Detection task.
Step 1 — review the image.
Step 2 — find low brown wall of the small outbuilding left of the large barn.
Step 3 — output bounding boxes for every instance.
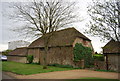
[7,56,27,63]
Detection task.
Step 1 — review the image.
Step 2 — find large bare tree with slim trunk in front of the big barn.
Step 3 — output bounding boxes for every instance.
[9,1,77,69]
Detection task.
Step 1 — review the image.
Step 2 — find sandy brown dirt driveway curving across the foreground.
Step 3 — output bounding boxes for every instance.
[6,70,118,79]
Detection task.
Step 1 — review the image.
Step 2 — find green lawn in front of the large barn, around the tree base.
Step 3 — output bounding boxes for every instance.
[2,61,73,75]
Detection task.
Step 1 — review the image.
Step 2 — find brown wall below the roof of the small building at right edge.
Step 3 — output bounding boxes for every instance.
[108,54,120,72]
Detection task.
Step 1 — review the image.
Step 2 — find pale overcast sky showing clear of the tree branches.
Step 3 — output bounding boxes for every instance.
[0,0,108,52]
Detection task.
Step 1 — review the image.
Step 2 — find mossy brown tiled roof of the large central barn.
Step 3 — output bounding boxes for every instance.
[29,28,90,47]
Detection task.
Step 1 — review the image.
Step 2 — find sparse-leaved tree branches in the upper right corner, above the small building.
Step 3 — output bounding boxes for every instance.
[87,0,120,41]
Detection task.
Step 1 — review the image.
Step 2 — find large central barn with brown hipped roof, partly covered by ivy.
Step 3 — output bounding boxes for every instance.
[27,28,93,67]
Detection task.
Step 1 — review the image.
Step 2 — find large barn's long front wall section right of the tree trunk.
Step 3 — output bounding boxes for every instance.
[48,46,73,65]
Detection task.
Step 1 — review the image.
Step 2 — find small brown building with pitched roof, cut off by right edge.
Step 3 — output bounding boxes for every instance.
[103,40,120,72]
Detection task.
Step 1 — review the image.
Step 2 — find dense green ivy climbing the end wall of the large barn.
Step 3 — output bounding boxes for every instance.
[73,43,93,67]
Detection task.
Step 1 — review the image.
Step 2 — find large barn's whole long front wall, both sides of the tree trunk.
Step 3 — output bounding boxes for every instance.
[28,46,74,65]
